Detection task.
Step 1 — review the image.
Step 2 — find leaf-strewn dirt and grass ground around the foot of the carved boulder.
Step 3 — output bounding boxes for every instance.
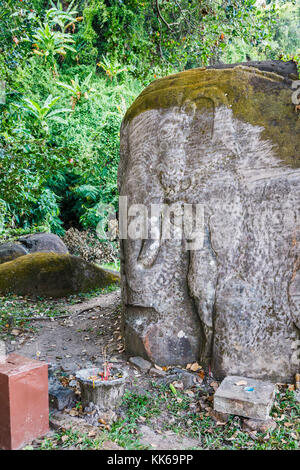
[2,290,300,450]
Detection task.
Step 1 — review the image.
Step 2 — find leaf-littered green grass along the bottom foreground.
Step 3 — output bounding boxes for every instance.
[34,385,300,450]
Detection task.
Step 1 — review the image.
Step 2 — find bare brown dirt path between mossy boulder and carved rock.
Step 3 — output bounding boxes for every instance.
[15,290,123,372]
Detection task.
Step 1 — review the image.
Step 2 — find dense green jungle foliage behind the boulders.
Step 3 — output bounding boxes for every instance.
[0,0,300,236]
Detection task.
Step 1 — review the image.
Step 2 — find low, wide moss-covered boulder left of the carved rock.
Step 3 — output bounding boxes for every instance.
[0,253,119,297]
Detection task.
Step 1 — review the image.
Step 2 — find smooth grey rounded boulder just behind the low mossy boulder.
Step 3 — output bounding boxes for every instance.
[18,233,68,254]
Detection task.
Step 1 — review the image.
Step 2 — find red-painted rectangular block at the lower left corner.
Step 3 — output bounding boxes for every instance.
[0,354,49,450]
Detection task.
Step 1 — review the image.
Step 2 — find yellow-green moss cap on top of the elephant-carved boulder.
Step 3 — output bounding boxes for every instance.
[123,65,300,168]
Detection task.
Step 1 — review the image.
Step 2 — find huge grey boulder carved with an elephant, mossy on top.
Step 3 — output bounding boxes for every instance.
[119,59,300,380]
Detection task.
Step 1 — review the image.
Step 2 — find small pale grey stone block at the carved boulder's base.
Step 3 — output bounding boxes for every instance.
[214,376,275,420]
